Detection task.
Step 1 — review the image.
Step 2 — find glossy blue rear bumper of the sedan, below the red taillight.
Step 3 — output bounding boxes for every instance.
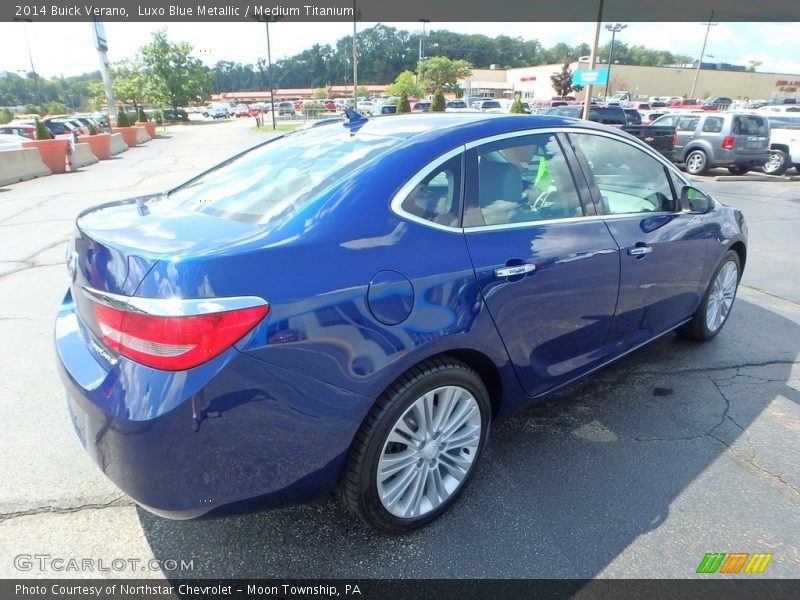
[56,295,372,519]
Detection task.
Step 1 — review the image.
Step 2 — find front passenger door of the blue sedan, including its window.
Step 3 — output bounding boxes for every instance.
[570,132,709,355]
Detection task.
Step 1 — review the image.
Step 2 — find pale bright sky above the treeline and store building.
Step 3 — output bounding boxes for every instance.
[0,22,800,77]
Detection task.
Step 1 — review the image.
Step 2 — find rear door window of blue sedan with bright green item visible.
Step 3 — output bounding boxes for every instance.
[472,133,584,225]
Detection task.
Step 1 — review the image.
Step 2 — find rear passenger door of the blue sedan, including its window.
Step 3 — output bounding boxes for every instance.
[464,132,619,395]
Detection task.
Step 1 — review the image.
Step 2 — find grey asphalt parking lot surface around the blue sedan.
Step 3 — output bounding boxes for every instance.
[0,119,800,578]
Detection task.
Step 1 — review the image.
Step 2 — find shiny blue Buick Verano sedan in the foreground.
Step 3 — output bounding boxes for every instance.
[55,112,747,532]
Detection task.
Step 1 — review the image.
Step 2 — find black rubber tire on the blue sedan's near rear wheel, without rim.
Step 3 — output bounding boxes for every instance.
[338,357,491,533]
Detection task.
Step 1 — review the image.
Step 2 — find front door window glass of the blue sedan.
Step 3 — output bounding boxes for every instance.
[573,134,676,215]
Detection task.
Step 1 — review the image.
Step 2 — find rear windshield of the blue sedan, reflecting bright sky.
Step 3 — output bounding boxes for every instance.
[168,124,398,223]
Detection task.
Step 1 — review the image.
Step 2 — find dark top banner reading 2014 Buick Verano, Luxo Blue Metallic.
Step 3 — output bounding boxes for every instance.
[0,0,800,24]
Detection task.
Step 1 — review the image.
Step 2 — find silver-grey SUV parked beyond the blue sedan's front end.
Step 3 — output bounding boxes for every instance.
[672,113,770,175]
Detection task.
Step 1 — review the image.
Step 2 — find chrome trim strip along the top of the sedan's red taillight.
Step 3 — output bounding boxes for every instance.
[81,285,269,317]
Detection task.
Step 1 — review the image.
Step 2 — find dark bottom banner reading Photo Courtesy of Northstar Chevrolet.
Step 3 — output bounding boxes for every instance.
[0,575,800,600]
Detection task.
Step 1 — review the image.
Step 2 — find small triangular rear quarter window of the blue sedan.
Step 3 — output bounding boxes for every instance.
[401,155,461,227]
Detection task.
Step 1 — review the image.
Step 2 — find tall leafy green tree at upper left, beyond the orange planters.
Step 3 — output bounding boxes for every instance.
[141,29,212,113]
